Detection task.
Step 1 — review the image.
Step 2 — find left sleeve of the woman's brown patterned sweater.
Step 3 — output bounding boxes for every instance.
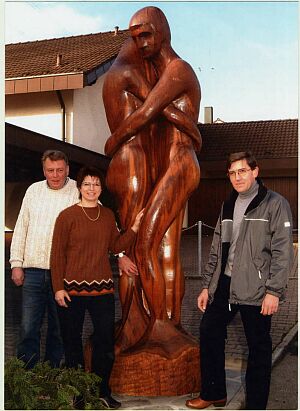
[50,212,71,293]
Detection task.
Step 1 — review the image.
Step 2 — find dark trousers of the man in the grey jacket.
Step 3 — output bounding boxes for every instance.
[200,275,272,410]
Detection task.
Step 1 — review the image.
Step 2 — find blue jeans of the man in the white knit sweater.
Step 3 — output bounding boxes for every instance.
[17,268,63,368]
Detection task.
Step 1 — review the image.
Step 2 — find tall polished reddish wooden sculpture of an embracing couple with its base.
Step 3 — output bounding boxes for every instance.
[103,7,201,395]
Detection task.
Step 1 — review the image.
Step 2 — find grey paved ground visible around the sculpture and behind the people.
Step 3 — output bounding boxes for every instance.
[5,235,298,410]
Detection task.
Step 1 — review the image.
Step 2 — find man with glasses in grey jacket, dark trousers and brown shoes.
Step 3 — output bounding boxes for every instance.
[186,152,293,409]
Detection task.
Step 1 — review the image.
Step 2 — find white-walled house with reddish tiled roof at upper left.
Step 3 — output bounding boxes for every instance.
[5,27,129,153]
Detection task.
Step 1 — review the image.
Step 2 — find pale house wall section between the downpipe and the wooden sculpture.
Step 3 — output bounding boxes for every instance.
[73,75,110,154]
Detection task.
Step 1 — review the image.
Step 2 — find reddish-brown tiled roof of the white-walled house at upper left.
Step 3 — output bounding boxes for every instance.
[5,30,129,79]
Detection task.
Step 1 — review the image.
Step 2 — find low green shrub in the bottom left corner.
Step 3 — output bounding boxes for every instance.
[4,358,103,410]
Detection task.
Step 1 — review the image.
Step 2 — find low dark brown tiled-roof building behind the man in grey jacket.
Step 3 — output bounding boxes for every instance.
[189,119,298,227]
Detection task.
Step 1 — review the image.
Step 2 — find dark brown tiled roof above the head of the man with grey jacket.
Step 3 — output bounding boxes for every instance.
[198,120,298,161]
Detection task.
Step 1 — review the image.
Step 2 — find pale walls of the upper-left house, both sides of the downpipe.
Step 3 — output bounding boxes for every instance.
[5,75,110,154]
